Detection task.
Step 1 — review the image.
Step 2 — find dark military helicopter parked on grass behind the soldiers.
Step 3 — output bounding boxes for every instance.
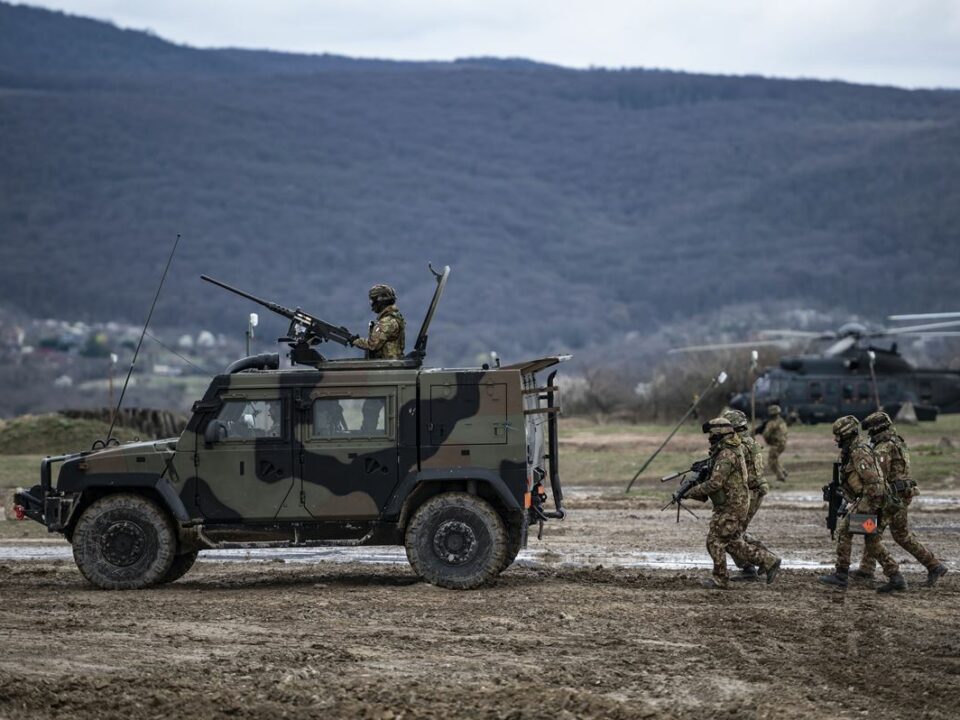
[670,313,960,423]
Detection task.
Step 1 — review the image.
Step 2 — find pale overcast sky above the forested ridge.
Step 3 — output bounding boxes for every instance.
[18,0,960,88]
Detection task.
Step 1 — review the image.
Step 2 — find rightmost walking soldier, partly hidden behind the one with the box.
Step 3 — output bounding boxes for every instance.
[851,412,947,586]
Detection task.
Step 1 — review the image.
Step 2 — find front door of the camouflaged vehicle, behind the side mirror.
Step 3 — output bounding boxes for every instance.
[196,389,295,522]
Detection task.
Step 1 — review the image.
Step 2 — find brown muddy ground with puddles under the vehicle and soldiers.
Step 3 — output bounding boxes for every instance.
[0,487,960,720]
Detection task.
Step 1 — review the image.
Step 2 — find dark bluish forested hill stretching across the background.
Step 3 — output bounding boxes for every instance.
[0,4,960,362]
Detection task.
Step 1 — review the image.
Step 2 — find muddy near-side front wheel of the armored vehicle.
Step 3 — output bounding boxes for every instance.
[73,494,177,590]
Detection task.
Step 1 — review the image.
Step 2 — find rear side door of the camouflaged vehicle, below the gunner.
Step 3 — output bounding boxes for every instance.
[297,386,399,520]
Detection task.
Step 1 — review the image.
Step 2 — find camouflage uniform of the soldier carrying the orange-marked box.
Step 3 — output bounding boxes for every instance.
[837,430,900,578]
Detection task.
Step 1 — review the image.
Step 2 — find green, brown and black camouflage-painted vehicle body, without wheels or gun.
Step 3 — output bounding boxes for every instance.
[39,360,553,547]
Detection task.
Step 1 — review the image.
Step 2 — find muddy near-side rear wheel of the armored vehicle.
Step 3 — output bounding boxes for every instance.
[406,492,507,590]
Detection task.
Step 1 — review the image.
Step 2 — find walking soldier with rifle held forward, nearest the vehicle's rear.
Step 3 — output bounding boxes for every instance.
[686,417,780,589]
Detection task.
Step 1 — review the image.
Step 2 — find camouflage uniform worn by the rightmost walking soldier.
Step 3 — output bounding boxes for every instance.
[858,423,940,577]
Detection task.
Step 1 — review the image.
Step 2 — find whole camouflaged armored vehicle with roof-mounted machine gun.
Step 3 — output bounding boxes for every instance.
[15,268,565,589]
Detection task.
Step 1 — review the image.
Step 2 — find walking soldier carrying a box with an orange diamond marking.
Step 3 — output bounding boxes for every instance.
[820,415,907,593]
